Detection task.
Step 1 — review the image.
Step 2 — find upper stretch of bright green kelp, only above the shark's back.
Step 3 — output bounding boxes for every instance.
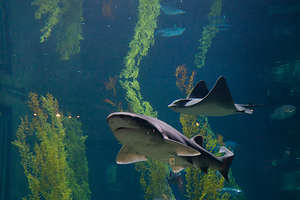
[120,0,160,117]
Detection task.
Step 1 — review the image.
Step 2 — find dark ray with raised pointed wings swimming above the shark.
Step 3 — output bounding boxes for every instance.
[168,76,255,116]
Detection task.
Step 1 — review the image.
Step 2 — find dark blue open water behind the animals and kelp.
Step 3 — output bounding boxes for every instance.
[0,0,300,200]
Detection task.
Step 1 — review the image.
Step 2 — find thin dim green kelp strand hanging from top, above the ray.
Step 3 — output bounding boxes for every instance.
[194,0,222,68]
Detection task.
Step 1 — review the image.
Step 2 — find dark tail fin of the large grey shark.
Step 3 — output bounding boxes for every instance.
[219,146,234,182]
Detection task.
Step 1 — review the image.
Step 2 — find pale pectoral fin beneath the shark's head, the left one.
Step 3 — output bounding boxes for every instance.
[116,145,147,164]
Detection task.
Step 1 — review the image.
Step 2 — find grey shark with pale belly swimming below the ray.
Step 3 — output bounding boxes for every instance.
[107,112,234,181]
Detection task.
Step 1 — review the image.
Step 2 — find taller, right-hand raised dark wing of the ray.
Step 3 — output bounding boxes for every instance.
[204,76,236,110]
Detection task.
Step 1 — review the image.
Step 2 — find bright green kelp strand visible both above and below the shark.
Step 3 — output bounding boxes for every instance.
[120,0,176,199]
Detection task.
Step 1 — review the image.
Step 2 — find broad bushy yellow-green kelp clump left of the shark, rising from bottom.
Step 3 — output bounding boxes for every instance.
[12,93,90,200]
